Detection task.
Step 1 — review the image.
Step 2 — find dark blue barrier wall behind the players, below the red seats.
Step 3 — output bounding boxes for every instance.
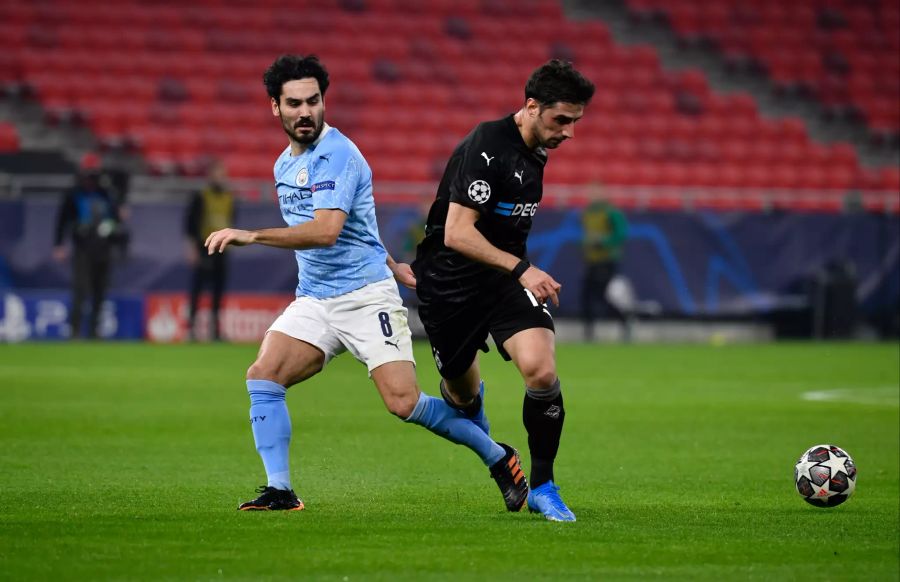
[0,201,900,316]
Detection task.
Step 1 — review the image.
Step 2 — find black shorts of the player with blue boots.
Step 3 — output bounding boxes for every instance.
[419,276,555,380]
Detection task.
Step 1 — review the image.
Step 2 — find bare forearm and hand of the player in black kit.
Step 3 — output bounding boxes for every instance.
[444,202,562,306]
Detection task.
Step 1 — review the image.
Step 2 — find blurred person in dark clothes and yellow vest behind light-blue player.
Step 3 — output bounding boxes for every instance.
[185,162,235,341]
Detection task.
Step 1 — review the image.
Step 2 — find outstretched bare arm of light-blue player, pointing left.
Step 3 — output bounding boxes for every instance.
[205,208,347,254]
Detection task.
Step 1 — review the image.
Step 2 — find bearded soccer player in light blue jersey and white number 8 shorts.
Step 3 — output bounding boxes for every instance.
[206,55,528,511]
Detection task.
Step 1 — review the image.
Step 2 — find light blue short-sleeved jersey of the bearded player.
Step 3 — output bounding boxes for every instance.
[275,124,391,299]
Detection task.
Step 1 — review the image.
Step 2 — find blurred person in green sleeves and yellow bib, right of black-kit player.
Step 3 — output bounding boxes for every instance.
[581,199,631,341]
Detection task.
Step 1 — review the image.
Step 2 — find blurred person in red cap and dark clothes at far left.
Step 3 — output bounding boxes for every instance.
[53,153,128,339]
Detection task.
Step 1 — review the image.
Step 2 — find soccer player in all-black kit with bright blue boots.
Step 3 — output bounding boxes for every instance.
[413,60,594,521]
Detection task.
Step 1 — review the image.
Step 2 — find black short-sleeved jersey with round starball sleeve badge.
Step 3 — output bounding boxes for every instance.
[413,115,547,302]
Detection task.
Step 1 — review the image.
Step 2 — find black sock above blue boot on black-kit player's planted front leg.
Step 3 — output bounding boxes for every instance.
[522,379,566,489]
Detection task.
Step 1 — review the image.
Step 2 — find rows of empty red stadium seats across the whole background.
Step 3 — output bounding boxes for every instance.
[0,0,900,210]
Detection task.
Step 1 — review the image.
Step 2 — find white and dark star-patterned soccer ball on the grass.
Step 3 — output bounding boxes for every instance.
[794,445,856,507]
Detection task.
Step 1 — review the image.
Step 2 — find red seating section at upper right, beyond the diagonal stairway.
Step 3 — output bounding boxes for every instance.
[628,0,900,136]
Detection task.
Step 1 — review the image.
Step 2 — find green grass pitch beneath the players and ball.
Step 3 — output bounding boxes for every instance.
[0,344,900,582]
